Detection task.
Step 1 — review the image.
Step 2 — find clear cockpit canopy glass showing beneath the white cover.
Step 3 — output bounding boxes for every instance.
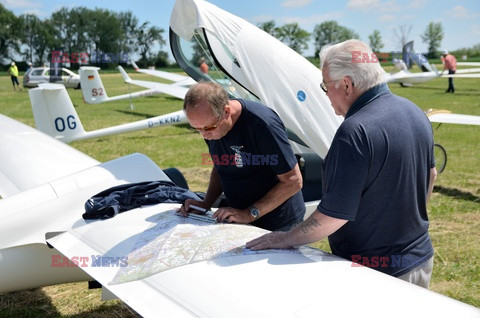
[170,29,258,101]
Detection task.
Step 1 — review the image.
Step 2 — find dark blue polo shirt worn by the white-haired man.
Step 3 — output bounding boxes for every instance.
[318,84,435,276]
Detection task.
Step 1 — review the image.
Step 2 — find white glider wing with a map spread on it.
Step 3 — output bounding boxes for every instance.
[48,204,479,318]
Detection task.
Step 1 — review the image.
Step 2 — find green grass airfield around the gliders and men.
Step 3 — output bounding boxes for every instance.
[0,66,480,317]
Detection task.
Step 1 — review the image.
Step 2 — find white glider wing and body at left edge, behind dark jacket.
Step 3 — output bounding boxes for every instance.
[0,115,174,293]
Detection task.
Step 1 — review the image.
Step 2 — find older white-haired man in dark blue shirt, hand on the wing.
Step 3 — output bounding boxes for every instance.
[246,40,437,287]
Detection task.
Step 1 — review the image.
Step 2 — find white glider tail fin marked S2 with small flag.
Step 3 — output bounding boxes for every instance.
[78,66,109,104]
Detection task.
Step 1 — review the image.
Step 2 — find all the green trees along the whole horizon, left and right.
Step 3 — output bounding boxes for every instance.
[0,3,480,68]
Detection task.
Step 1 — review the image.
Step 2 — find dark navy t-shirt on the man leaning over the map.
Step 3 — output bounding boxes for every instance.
[205,99,305,231]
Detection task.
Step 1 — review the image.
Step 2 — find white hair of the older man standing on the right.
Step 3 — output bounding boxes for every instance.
[320,40,386,93]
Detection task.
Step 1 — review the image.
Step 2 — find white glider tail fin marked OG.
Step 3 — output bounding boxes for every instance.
[28,83,85,142]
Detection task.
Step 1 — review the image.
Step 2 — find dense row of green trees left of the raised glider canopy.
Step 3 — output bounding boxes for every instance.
[0,3,168,67]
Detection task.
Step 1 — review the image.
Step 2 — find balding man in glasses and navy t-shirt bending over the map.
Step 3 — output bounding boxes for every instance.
[181,82,305,231]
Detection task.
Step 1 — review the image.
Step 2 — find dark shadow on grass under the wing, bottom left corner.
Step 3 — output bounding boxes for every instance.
[0,288,141,318]
